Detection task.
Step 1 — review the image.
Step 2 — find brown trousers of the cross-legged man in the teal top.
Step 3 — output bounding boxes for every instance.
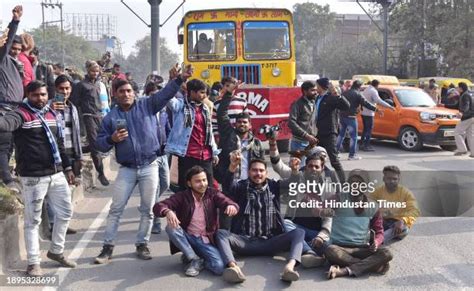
[324,245,392,277]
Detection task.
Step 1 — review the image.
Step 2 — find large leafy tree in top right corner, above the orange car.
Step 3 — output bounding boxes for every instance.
[389,0,474,78]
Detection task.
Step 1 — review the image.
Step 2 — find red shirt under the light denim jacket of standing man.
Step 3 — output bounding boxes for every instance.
[186,105,212,161]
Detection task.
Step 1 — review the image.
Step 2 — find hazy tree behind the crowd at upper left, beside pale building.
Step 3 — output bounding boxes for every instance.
[28,26,101,71]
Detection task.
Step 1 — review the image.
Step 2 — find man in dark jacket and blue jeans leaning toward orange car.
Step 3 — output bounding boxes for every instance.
[336,80,377,160]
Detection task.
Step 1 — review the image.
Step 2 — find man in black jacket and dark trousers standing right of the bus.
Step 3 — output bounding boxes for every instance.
[315,78,350,182]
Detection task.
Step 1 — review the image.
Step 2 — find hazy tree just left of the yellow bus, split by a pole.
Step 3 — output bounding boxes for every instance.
[122,35,178,82]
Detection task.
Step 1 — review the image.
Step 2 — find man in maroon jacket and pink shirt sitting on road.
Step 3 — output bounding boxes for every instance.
[153,166,239,277]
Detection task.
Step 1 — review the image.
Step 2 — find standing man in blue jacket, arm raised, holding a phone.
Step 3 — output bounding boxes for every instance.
[95,68,192,264]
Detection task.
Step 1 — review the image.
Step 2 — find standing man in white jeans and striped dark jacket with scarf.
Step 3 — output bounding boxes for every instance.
[0,81,76,276]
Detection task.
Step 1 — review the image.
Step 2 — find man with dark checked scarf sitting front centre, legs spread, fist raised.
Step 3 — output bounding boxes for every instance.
[216,153,304,283]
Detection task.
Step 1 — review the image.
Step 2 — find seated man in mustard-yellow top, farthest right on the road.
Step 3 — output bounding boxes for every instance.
[371,166,420,243]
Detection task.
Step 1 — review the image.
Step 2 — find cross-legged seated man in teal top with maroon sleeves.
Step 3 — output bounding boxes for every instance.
[324,170,392,279]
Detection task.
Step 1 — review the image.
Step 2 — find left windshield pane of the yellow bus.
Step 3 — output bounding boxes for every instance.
[188,22,236,61]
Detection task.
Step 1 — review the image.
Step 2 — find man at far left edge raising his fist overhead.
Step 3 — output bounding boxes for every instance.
[0,5,23,193]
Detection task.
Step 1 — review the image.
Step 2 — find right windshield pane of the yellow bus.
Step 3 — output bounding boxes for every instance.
[244,21,291,60]
